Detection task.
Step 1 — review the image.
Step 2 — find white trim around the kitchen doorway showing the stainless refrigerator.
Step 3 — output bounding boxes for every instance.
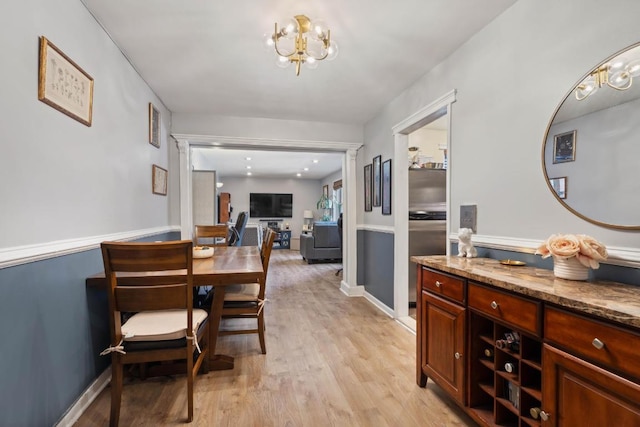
[392,89,456,331]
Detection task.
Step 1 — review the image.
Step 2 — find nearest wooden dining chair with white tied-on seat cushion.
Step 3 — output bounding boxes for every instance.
[101,240,209,426]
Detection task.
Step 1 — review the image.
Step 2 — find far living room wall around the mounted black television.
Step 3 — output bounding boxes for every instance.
[220,176,322,237]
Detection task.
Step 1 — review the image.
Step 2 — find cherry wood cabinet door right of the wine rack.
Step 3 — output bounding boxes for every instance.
[542,345,640,427]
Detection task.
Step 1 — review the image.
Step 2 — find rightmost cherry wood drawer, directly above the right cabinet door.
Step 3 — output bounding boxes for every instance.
[544,307,640,378]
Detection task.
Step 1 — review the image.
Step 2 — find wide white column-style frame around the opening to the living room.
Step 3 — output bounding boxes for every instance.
[171,134,362,296]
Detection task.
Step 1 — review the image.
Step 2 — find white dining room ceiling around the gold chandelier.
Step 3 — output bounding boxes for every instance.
[81,0,516,177]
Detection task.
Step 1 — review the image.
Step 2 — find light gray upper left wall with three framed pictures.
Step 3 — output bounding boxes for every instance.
[0,0,179,248]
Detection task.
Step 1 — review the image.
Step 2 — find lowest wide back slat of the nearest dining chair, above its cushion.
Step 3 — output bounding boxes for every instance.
[115,283,192,312]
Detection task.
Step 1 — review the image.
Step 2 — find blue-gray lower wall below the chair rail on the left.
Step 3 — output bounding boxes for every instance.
[0,232,180,426]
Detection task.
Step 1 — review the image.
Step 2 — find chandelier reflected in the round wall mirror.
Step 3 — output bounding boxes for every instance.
[575,57,640,101]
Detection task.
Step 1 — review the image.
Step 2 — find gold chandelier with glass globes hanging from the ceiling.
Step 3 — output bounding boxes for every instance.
[265,15,338,76]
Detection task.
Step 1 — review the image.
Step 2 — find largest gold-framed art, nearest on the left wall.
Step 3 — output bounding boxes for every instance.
[38,36,93,126]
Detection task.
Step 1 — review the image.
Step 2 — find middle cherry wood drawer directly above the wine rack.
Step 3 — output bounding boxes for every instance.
[468,283,542,337]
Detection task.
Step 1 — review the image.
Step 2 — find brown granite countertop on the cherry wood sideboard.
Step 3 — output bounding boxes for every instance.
[411,255,640,328]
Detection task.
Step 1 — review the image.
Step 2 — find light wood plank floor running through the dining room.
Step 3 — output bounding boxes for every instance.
[76,250,475,427]
